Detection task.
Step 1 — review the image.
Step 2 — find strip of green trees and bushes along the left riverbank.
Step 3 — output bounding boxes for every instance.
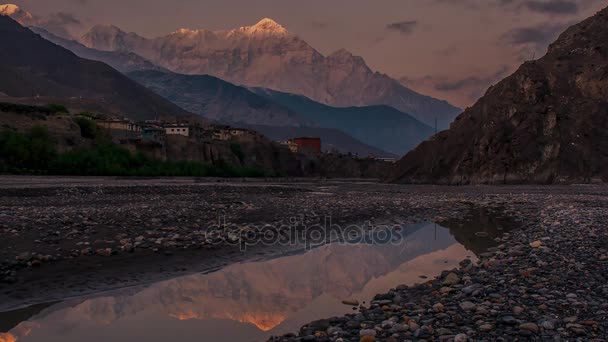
[0,125,264,177]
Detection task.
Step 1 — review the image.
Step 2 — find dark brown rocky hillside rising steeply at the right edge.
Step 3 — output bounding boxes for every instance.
[390,9,608,184]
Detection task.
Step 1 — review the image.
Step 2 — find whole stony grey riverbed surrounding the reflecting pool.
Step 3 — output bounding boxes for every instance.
[0,177,608,341]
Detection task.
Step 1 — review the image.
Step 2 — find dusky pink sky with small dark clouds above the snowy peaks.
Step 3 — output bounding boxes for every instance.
[11,0,608,108]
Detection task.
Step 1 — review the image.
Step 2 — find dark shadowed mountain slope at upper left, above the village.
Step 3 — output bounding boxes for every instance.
[0,15,187,119]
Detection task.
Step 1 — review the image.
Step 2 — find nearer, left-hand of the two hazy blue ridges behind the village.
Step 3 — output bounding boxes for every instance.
[127,71,391,156]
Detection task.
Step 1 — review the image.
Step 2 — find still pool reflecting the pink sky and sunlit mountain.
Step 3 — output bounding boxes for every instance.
[0,219,510,342]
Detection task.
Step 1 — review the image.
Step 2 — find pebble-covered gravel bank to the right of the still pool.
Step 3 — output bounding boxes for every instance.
[273,186,608,341]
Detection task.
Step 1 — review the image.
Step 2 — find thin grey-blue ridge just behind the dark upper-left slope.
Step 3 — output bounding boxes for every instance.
[29,26,164,73]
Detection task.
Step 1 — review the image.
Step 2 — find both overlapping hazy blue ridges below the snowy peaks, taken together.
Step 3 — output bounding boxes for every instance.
[128,71,433,156]
